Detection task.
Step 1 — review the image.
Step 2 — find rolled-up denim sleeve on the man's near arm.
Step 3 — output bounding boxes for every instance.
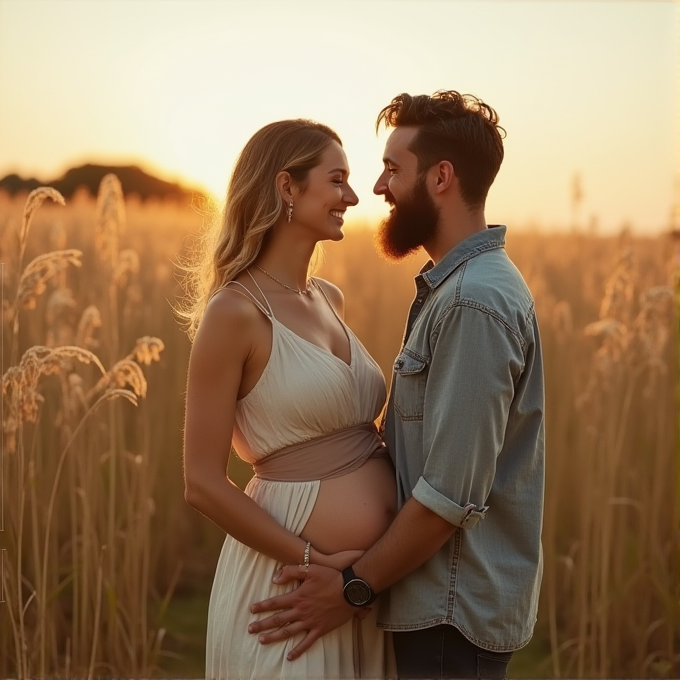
[413,303,524,529]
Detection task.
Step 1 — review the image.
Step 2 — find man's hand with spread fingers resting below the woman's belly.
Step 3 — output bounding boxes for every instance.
[248,564,370,661]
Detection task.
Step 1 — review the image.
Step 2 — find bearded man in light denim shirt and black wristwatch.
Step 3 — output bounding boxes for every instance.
[249,91,545,678]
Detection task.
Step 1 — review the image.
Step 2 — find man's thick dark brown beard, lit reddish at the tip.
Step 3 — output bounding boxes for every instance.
[375,177,439,260]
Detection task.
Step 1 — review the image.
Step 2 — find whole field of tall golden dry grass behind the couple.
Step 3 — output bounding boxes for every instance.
[0,182,680,678]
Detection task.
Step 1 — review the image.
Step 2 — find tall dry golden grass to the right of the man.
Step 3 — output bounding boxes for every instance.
[504,233,680,677]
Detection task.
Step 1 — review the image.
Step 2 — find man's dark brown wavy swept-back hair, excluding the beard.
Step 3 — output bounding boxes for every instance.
[375,90,505,208]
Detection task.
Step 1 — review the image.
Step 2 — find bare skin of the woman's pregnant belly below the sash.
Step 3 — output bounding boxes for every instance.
[302,458,397,554]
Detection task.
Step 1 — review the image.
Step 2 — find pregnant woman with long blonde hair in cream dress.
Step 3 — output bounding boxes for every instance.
[184,120,396,680]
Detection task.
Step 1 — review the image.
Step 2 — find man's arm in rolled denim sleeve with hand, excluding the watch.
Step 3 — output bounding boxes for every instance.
[249,306,523,658]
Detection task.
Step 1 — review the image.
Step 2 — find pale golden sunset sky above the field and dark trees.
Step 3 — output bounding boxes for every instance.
[0,0,680,231]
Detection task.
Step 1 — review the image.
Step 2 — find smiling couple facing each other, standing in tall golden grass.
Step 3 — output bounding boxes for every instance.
[184,91,544,680]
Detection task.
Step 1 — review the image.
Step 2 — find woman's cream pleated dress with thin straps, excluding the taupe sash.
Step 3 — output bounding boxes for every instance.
[206,284,391,680]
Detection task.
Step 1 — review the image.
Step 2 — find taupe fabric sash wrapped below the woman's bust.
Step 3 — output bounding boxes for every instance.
[253,423,389,482]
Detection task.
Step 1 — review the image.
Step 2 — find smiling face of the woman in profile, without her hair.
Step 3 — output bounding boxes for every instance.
[292,141,359,241]
